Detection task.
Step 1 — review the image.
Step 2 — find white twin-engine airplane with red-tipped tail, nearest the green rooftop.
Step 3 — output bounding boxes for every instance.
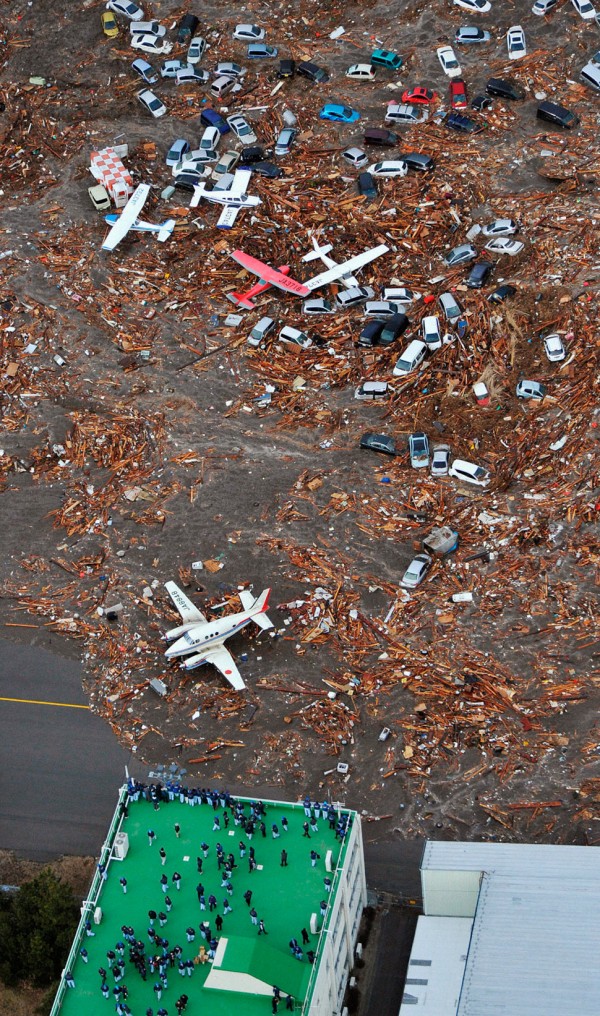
[162,582,273,692]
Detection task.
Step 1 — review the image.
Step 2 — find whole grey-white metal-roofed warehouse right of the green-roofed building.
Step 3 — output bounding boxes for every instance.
[400,842,600,1016]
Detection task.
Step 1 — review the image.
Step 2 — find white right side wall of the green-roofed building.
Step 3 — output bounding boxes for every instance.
[303,815,366,1016]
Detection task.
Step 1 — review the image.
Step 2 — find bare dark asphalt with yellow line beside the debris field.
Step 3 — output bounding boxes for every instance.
[0,639,145,861]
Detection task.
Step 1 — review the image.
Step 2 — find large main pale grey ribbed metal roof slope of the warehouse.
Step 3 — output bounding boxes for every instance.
[454,873,600,1016]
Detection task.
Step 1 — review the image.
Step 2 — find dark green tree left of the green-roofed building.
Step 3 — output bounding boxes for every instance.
[0,868,79,988]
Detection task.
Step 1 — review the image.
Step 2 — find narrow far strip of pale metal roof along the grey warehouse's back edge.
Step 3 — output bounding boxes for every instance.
[421,840,600,884]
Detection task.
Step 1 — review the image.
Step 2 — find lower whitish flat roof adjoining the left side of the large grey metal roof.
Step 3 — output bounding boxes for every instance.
[400,917,473,1016]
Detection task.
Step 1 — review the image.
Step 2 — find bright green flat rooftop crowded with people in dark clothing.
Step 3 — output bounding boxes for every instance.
[53,799,355,1016]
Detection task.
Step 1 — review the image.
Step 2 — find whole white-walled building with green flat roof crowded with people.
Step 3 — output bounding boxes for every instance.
[52,787,366,1016]
